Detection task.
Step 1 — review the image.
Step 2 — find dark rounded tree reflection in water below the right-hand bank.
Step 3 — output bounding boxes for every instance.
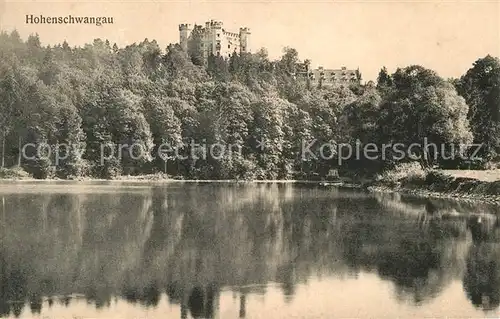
[344,196,465,304]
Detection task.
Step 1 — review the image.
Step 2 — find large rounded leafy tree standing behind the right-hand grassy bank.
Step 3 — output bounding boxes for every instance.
[378,65,472,167]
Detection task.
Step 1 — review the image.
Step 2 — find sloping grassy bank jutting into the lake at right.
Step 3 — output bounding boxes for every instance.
[372,165,500,203]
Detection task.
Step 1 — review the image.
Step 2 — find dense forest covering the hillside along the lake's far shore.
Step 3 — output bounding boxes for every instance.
[0,31,500,179]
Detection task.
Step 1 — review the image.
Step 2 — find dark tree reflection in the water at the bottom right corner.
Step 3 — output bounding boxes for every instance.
[463,243,500,310]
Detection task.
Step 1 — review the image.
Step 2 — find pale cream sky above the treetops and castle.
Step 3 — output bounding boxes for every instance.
[0,0,500,81]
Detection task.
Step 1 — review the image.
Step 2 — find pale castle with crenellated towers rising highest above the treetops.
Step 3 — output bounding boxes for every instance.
[179,20,250,58]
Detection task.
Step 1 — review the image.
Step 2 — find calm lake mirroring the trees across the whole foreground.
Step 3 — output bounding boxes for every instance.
[0,182,500,319]
